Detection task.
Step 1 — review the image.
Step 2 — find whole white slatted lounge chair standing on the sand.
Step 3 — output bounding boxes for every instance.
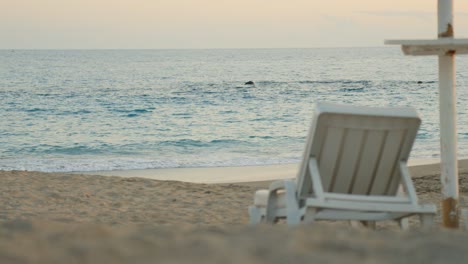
[249,103,437,229]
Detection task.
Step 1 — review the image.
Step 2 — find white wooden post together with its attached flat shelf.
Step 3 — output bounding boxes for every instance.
[385,0,468,228]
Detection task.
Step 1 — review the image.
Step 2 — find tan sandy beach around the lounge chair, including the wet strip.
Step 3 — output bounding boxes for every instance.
[0,160,468,264]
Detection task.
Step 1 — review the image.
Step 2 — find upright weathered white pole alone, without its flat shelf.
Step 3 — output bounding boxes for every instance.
[438,0,458,228]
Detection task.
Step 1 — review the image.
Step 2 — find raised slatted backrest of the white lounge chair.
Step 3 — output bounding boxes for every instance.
[297,103,421,197]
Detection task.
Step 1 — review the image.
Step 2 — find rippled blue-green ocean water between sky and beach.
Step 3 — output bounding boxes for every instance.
[0,47,468,172]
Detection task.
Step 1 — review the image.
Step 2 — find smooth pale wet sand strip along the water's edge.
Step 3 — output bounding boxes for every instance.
[78,158,468,184]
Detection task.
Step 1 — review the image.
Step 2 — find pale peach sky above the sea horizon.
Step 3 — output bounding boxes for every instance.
[0,0,468,49]
